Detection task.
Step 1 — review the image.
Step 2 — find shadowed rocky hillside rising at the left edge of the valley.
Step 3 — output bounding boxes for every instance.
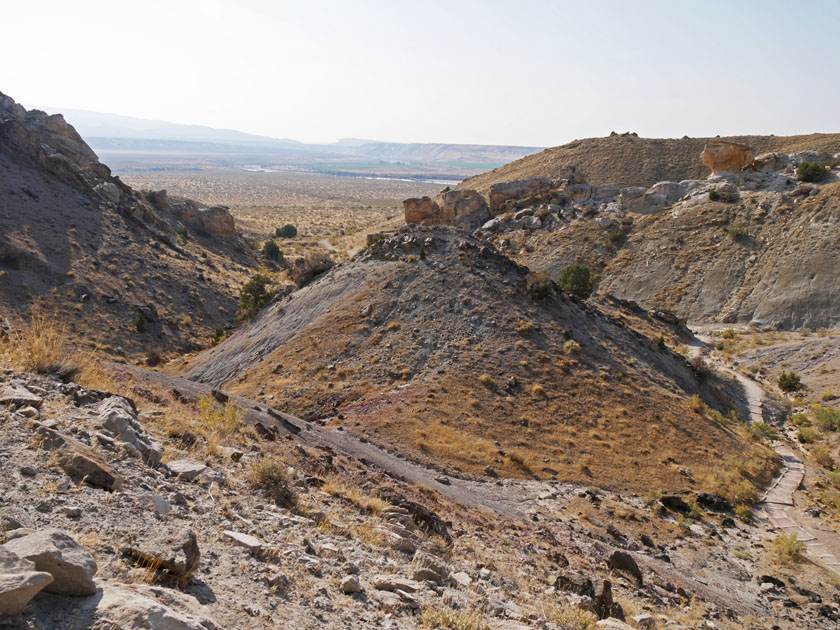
[0,94,254,356]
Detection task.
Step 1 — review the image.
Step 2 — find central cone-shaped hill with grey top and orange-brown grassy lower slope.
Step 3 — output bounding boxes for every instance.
[180,228,776,498]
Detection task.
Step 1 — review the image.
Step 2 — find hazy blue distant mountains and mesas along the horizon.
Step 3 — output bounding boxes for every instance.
[32,108,542,178]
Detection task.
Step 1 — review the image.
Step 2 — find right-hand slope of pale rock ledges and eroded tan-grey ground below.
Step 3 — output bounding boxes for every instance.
[452,142,840,329]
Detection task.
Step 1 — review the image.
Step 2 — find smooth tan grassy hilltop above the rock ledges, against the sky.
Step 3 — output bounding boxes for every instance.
[458,134,840,196]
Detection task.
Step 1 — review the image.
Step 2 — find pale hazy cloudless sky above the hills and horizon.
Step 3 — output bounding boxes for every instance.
[0,0,840,146]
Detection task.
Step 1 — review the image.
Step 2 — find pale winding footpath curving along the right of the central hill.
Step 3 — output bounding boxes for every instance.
[694,334,840,574]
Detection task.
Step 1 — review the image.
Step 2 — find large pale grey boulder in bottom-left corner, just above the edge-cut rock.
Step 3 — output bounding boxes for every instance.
[3,529,97,596]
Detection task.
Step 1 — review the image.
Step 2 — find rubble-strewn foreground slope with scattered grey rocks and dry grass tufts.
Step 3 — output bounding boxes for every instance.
[0,360,840,630]
